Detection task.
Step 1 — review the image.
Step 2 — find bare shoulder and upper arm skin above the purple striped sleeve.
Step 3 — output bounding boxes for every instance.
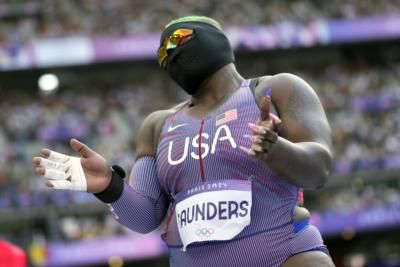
[136,102,186,159]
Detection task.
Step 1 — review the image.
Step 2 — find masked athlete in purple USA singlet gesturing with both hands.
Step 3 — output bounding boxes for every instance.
[33,16,334,267]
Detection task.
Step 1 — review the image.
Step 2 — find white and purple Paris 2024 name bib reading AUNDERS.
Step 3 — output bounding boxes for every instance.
[175,180,252,251]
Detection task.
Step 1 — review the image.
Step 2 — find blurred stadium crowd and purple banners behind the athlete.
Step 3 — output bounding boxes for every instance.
[0,0,400,267]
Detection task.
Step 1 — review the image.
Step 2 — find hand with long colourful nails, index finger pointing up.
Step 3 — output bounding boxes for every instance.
[240,89,281,158]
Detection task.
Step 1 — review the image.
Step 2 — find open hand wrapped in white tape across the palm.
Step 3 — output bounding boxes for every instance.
[32,139,111,193]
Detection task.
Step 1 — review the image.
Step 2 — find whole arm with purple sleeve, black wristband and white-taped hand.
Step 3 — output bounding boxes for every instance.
[33,112,169,233]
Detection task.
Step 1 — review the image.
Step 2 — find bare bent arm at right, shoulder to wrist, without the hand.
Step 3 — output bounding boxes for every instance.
[256,73,333,189]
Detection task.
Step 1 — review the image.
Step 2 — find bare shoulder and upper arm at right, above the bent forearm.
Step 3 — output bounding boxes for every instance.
[255,73,331,147]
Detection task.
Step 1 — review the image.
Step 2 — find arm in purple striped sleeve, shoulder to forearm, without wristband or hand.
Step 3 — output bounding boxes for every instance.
[104,111,169,233]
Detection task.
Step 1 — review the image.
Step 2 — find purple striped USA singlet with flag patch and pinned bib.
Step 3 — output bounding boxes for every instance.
[156,80,326,267]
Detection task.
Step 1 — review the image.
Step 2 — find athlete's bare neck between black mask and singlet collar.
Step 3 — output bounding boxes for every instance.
[191,63,244,108]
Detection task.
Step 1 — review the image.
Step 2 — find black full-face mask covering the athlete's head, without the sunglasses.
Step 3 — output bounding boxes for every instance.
[160,21,234,95]
